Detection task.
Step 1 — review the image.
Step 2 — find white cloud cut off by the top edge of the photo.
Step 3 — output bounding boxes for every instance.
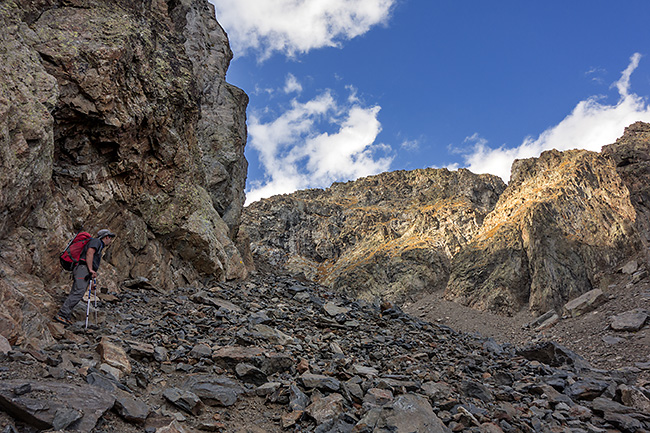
[210,0,397,59]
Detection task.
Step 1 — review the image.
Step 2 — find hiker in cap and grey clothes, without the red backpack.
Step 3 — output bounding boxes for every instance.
[54,229,115,325]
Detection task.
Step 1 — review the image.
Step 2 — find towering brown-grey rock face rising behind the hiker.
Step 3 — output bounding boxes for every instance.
[0,0,248,342]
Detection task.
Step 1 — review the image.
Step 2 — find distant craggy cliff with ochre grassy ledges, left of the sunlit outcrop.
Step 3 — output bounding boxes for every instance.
[242,169,505,299]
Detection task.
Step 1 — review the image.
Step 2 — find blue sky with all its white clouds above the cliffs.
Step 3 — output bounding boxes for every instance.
[211,0,650,202]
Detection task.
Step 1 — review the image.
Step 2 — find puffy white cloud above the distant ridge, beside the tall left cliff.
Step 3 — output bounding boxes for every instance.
[246,92,392,203]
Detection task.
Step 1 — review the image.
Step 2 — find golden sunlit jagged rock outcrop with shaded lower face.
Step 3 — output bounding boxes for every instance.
[446,150,640,314]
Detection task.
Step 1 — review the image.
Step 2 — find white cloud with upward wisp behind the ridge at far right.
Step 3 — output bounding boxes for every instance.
[456,53,650,181]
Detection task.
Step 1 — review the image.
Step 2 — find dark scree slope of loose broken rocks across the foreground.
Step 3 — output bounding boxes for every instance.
[0,275,650,433]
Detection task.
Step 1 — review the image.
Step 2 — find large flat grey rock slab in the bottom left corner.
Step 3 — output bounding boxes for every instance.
[0,379,115,432]
